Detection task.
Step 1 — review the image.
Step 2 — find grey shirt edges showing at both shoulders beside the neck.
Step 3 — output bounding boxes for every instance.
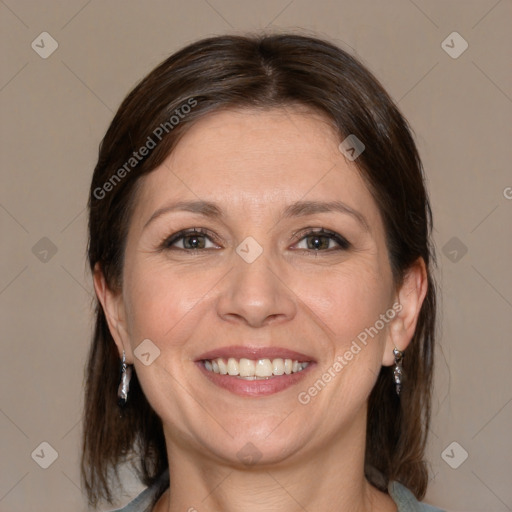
[108,470,443,512]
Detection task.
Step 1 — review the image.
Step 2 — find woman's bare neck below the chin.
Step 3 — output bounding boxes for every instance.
[155,412,397,512]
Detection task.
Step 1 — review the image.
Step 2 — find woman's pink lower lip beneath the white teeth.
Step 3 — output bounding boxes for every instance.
[196,361,315,396]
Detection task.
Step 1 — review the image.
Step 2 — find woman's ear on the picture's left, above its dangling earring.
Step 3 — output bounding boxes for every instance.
[93,263,133,364]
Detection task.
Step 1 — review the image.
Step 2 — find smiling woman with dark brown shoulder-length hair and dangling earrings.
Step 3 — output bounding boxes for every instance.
[82,34,438,512]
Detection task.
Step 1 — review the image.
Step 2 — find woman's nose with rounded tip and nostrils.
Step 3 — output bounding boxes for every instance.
[217,249,297,327]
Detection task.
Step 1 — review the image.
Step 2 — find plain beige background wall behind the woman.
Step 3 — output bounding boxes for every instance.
[0,0,512,512]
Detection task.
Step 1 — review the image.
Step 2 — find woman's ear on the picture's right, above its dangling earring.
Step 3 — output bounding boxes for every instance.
[382,258,428,366]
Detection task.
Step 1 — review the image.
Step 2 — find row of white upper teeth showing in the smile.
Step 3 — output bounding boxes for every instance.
[204,357,309,380]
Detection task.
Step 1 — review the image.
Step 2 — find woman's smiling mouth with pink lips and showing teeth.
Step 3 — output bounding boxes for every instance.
[195,346,316,396]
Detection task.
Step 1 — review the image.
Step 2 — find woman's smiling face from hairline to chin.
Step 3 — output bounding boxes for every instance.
[110,108,399,464]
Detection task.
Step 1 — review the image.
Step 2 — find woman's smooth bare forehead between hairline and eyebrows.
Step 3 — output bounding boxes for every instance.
[130,107,379,227]
